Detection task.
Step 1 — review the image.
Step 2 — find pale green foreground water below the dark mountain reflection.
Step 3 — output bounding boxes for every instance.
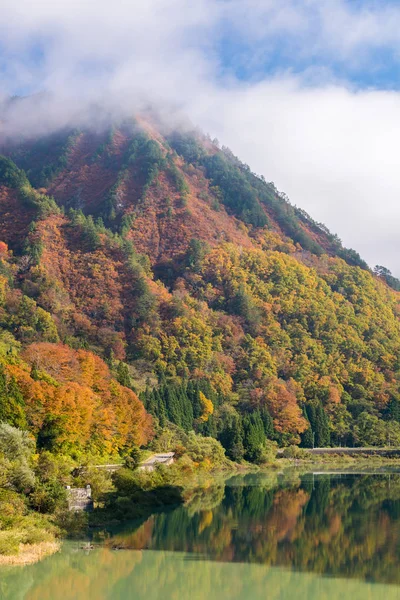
[4,549,398,600]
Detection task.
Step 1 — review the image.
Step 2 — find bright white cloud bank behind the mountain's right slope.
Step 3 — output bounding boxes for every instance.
[196,80,400,275]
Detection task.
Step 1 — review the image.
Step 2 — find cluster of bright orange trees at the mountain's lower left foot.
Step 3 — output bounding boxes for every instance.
[13,343,153,453]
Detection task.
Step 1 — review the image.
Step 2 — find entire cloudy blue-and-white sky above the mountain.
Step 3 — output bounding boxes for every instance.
[0,0,400,277]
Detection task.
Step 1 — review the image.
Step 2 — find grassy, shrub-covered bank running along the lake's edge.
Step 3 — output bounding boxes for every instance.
[0,426,400,565]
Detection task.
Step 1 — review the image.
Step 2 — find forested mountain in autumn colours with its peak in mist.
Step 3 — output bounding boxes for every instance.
[0,115,400,461]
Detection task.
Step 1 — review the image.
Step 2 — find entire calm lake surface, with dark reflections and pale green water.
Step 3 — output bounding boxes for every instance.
[0,474,400,600]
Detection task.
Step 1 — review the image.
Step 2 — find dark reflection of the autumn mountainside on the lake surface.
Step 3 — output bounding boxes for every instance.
[112,475,400,582]
